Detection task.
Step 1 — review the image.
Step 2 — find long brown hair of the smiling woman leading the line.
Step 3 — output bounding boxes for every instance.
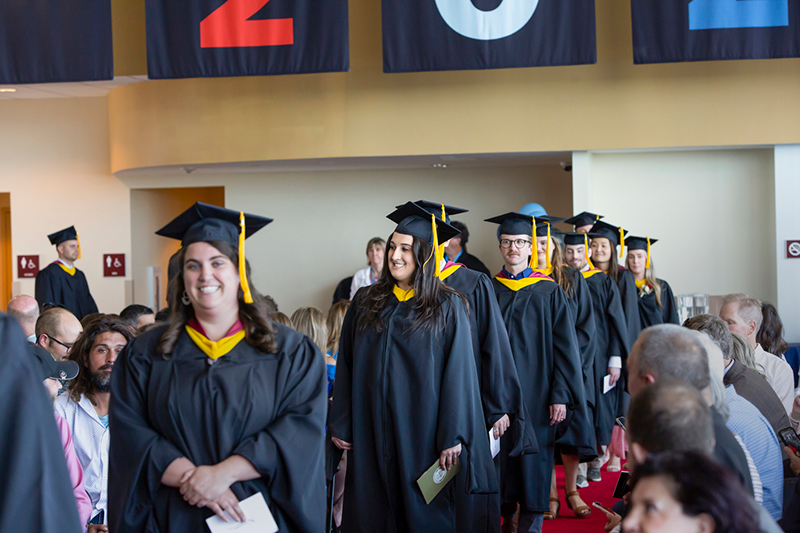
[158,241,277,359]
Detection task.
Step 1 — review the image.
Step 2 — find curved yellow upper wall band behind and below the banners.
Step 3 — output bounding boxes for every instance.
[109,0,800,172]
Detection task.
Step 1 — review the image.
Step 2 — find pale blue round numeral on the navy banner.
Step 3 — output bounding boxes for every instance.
[436,0,539,41]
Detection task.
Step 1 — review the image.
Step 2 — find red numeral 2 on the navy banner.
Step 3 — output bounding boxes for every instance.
[200,0,294,48]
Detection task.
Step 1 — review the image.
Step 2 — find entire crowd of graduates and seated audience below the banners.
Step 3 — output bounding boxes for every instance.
[0,201,800,533]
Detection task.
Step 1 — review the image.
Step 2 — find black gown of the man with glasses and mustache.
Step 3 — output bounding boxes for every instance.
[492,274,594,513]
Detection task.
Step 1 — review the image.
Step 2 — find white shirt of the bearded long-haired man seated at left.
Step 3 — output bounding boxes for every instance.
[55,394,110,524]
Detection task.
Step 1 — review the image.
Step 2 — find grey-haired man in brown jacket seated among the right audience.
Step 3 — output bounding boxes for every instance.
[683,315,791,442]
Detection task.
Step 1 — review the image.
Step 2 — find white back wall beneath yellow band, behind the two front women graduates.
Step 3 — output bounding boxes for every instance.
[122,165,572,314]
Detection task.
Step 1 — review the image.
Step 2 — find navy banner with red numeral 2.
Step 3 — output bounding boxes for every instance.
[145,0,350,79]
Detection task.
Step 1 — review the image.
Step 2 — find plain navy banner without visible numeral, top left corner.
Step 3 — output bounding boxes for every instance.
[0,0,114,84]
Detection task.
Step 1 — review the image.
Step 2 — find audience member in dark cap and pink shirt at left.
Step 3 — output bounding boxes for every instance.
[28,345,92,527]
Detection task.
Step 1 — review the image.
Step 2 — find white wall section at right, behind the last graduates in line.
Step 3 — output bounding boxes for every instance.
[574,149,776,302]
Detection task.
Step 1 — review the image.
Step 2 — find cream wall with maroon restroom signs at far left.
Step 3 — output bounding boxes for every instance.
[0,98,131,313]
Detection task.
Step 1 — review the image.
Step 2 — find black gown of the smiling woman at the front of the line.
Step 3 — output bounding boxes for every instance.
[108,324,327,533]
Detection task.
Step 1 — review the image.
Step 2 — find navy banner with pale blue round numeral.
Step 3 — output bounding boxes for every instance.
[382,0,597,72]
